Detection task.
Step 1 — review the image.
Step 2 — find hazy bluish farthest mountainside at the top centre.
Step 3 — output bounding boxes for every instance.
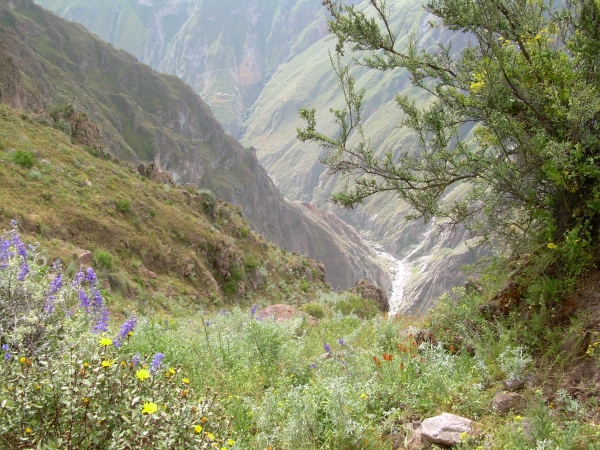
[37,0,327,138]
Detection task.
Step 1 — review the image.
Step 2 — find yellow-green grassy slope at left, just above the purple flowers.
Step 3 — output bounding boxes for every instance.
[0,106,328,314]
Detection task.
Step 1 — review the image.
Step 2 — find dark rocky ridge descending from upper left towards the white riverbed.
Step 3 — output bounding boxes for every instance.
[0,0,389,288]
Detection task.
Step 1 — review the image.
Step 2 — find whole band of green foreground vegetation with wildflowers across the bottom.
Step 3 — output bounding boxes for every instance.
[0,230,600,450]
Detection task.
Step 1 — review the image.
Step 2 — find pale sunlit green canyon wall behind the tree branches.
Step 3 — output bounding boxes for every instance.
[242,0,475,312]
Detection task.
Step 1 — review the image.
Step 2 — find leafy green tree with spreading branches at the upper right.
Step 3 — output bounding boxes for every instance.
[298,0,600,282]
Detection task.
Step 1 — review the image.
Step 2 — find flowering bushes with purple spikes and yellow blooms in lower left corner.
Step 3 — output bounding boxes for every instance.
[0,224,235,449]
